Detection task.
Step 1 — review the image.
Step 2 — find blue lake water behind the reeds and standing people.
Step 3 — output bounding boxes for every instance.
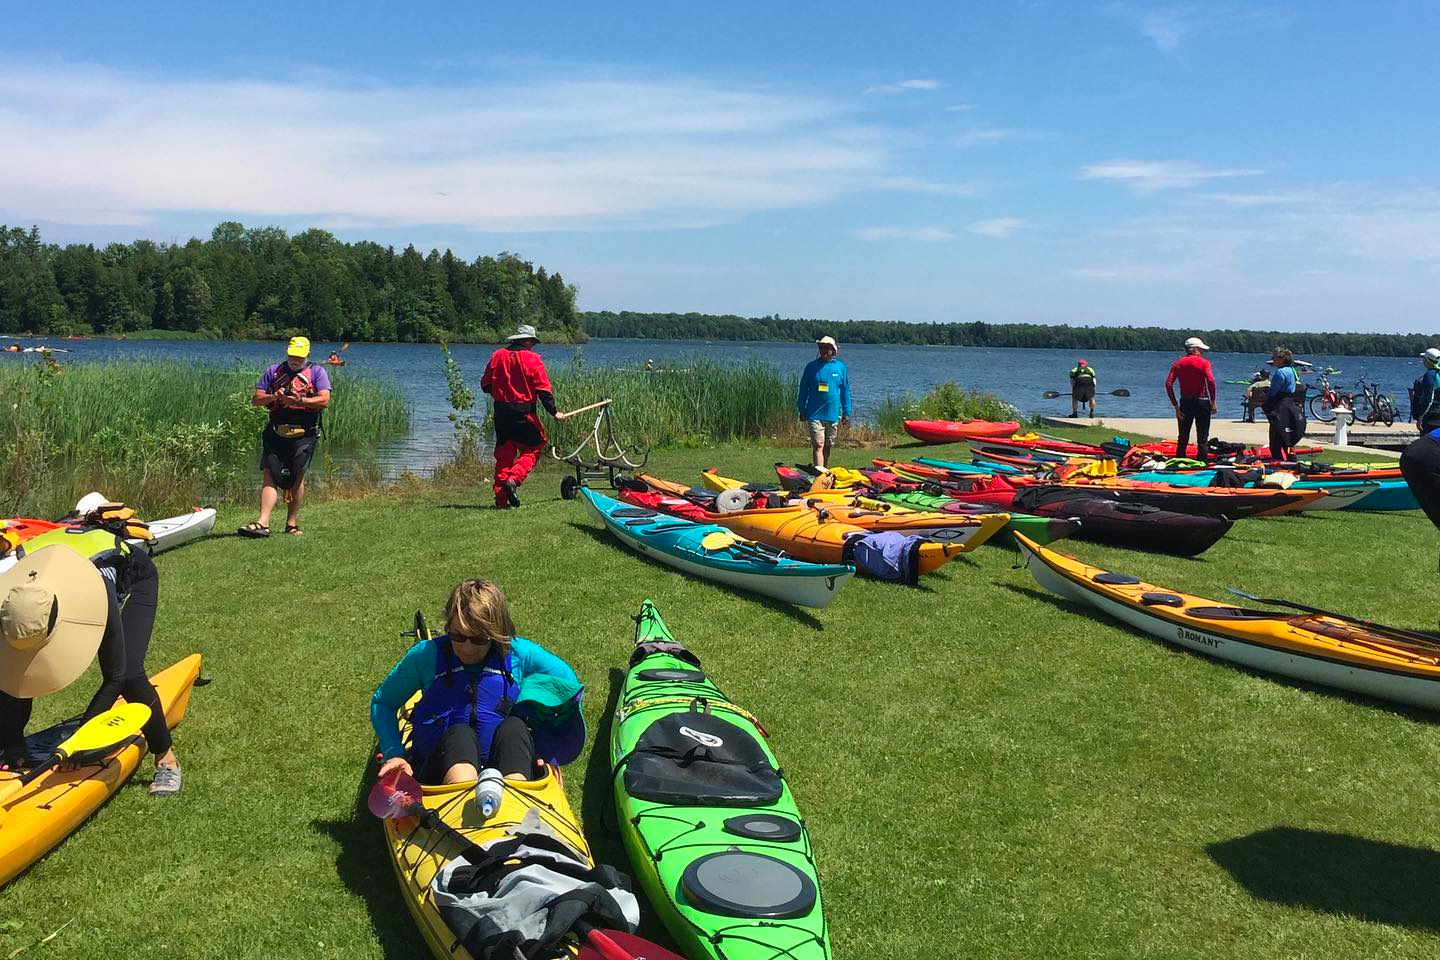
[0,338,1420,469]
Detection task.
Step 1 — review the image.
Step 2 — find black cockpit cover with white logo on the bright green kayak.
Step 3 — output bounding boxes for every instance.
[622,710,783,806]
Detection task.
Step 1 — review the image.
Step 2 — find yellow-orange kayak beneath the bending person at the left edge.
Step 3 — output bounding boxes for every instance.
[0,653,200,885]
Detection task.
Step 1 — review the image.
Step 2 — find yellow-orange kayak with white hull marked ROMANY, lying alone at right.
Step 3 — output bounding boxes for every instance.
[1020,538,1440,710]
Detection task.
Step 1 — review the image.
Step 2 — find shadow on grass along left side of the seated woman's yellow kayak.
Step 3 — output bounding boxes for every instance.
[310,759,429,960]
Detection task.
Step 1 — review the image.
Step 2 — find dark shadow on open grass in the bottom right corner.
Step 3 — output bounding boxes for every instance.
[1205,826,1440,933]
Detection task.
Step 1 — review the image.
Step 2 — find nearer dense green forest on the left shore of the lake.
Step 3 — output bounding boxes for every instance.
[0,222,580,341]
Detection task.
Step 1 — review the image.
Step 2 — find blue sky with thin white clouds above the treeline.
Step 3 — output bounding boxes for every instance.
[0,0,1440,331]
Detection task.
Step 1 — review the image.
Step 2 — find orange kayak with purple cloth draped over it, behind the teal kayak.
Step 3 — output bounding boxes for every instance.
[636,474,962,573]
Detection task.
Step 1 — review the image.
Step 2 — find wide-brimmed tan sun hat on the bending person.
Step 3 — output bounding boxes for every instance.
[0,544,109,698]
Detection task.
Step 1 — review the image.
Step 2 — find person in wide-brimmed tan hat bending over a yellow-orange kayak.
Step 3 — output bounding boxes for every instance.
[0,530,181,796]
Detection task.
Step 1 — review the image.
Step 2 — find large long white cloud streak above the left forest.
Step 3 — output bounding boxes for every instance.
[0,63,949,232]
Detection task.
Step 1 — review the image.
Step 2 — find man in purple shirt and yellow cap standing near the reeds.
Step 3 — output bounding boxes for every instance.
[236,337,330,537]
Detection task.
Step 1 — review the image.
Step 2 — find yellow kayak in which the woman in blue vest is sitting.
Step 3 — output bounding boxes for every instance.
[384,694,590,960]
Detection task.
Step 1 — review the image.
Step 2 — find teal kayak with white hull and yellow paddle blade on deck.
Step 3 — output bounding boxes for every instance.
[580,486,855,607]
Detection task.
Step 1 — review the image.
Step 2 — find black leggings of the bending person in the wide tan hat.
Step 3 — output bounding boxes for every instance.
[0,550,170,759]
